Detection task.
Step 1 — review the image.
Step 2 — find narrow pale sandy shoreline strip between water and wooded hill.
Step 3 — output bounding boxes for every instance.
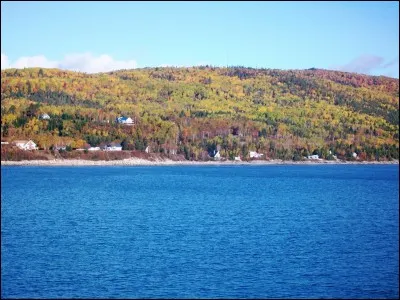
[1,158,399,167]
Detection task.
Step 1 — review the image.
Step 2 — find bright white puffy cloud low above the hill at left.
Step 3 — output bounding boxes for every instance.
[1,52,137,73]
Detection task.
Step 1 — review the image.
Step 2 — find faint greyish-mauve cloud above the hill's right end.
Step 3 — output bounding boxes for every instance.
[332,55,399,74]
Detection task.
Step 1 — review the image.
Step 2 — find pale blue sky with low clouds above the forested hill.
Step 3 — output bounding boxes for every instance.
[1,1,399,78]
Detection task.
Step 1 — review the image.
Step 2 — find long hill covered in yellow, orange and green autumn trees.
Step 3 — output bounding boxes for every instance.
[1,66,399,160]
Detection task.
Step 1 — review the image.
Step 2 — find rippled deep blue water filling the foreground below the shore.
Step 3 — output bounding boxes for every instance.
[1,165,399,298]
